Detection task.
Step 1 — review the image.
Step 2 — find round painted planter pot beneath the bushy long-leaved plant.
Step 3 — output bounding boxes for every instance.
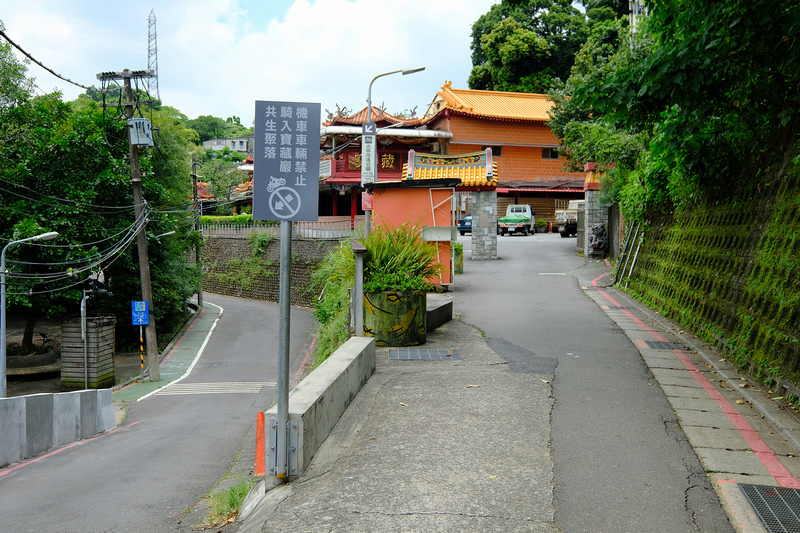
[364,291,428,346]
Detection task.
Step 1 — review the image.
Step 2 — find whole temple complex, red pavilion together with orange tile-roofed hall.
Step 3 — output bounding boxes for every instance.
[320,82,586,222]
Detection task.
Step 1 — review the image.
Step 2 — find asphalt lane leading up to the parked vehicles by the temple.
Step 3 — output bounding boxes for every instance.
[453,233,732,533]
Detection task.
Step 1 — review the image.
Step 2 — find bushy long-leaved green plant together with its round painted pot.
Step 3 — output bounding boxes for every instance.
[362,224,441,346]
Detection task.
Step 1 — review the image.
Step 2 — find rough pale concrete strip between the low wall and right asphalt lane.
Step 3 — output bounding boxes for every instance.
[239,321,556,532]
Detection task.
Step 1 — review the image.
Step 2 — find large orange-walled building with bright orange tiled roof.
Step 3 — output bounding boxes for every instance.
[423,82,586,221]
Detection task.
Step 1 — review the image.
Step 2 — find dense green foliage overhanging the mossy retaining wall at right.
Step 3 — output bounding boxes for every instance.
[554,0,800,218]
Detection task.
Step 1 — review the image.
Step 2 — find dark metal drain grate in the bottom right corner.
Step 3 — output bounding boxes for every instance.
[739,483,800,533]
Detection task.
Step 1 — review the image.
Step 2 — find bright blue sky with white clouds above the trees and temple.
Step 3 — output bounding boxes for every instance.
[0,0,497,126]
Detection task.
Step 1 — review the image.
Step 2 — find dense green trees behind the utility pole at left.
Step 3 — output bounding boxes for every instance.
[0,31,199,352]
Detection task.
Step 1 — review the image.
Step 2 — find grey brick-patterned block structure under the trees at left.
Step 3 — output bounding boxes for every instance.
[61,315,117,390]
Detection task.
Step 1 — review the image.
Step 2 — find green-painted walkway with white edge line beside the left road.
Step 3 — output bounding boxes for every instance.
[113,302,223,402]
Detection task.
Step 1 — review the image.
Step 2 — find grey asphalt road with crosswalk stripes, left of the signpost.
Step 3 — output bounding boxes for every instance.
[0,294,313,533]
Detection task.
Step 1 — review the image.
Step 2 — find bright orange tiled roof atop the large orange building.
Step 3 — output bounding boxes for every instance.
[425,81,553,121]
